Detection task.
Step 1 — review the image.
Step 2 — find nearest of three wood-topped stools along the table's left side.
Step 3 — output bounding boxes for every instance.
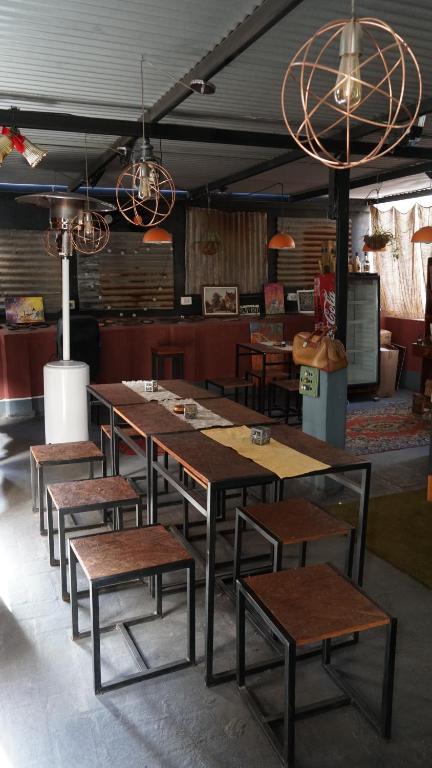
[69,525,195,693]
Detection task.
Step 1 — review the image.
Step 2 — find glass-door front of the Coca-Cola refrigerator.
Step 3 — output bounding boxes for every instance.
[346,272,380,392]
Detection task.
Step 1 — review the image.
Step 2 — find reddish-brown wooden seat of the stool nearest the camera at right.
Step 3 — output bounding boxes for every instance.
[245,563,390,646]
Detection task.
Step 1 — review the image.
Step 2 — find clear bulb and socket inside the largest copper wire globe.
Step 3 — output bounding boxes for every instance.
[334,19,362,110]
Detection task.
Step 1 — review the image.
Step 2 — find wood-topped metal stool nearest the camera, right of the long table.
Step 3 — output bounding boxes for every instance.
[237,564,397,768]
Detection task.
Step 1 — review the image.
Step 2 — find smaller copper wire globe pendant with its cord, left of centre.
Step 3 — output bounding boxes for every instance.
[116,57,175,227]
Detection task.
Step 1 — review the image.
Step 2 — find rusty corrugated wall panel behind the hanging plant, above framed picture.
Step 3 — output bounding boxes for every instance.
[186,208,267,293]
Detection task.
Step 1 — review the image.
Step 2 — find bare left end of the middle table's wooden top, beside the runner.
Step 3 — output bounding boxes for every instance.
[114,398,195,437]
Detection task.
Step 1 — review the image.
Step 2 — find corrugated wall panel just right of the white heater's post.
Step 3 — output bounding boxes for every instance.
[78,232,174,309]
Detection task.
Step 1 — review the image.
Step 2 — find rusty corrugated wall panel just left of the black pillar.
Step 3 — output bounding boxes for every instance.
[277,218,351,288]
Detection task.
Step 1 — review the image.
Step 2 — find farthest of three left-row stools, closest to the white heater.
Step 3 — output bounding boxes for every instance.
[30,440,106,536]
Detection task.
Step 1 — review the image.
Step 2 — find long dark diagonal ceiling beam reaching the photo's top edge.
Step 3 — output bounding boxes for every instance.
[69,0,303,191]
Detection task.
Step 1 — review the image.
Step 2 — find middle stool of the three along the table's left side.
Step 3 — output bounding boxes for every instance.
[47,475,142,602]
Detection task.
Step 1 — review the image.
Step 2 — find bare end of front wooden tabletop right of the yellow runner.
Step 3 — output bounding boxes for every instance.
[271,424,370,471]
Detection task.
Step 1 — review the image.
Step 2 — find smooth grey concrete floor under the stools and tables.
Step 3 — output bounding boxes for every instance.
[0,404,432,768]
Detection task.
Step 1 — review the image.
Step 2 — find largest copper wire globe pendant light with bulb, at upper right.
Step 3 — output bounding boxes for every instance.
[281,0,422,169]
